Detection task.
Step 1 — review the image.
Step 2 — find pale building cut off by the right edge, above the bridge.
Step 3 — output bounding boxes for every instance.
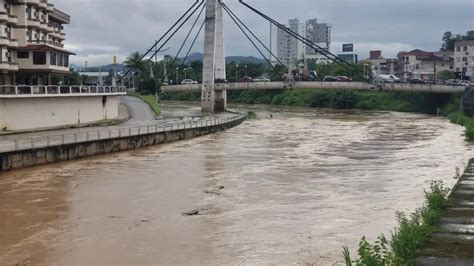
[454,40,474,81]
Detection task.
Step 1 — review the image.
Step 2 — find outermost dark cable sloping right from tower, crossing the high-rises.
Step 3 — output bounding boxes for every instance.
[239,0,362,74]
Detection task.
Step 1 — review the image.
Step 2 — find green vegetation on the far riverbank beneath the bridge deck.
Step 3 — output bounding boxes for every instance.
[161,89,451,114]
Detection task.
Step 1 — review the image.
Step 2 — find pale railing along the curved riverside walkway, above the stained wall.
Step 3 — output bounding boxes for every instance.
[0,114,245,153]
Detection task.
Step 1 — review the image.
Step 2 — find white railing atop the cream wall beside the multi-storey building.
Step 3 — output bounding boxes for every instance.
[0,85,127,97]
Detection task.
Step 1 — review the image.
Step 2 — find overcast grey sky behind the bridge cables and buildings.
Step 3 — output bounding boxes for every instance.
[50,0,474,66]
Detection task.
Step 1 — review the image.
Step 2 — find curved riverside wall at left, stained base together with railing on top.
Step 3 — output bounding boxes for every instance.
[0,114,246,172]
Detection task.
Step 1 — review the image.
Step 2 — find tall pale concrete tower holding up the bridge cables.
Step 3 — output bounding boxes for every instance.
[201,0,227,112]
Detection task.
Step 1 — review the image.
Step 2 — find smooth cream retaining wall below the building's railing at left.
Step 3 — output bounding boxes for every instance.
[0,95,119,131]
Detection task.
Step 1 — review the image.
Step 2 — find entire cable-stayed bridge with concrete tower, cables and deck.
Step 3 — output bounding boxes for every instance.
[118,0,466,112]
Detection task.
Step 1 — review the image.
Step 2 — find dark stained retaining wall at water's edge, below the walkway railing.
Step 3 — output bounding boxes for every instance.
[0,117,245,172]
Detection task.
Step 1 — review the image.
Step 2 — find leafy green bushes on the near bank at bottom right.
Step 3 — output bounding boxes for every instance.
[343,181,450,266]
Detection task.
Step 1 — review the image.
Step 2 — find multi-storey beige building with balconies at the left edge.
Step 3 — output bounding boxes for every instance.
[0,0,73,85]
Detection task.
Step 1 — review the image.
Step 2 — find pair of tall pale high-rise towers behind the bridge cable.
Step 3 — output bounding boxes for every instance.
[270,19,331,68]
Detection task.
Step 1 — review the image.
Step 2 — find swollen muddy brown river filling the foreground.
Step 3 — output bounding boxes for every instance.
[0,103,473,265]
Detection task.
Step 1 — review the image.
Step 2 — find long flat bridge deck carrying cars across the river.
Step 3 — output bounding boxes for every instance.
[162,82,465,93]
